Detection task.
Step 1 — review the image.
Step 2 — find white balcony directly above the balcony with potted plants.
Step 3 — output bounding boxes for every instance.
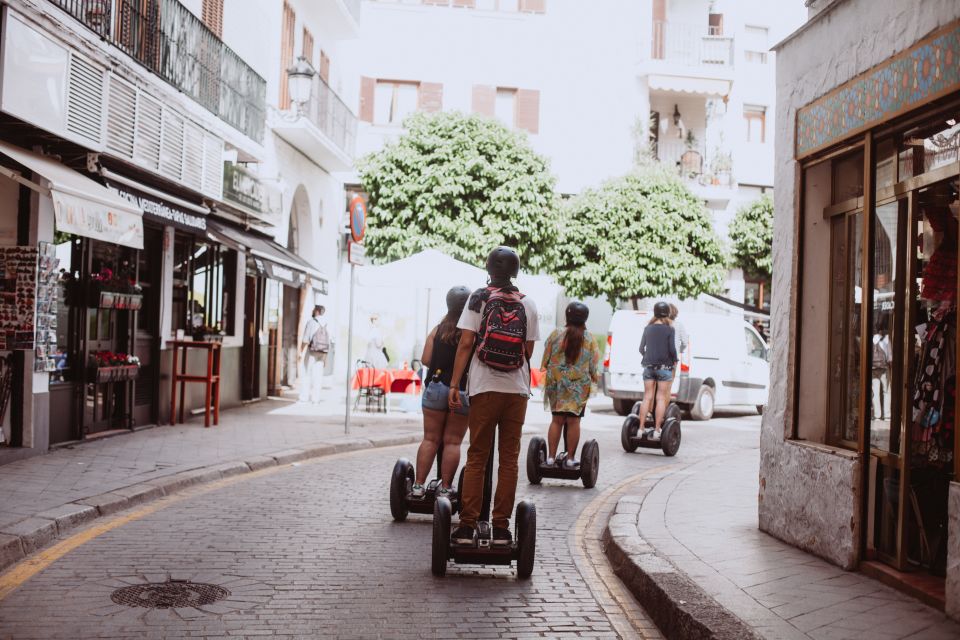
[640,21,734,96]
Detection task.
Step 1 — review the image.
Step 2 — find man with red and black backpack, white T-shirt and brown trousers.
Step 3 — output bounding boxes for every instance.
[450,247,540,546]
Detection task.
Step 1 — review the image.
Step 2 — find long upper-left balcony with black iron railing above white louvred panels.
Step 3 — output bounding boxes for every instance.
[50,0,267,143]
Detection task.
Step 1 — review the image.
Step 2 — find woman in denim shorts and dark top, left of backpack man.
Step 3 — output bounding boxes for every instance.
[411,287,470,498]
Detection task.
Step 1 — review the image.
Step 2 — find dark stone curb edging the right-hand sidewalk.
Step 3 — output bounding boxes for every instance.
[603,487,761,640]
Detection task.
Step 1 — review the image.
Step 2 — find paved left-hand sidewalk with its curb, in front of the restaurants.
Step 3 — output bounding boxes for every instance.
[0,394,422,570]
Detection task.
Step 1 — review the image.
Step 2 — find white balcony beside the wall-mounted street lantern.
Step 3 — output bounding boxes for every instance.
[270,74,357,171]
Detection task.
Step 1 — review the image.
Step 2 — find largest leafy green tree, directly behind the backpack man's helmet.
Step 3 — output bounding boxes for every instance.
[358,112,557,272]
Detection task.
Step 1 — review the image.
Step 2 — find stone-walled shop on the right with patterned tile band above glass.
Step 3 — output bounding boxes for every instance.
[760,0,960,612]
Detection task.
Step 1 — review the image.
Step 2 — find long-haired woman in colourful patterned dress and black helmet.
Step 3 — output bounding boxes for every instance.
[540,302,600,468]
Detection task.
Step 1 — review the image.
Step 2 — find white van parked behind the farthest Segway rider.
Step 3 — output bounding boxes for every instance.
[602,309,770,420]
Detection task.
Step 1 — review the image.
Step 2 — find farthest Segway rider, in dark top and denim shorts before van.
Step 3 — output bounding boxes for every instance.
[640,302,678,439]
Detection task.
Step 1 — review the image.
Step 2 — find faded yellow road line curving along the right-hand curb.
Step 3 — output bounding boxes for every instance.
[573,464,675,639]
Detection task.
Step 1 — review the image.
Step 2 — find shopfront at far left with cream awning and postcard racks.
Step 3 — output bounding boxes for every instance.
[0,143,144,451]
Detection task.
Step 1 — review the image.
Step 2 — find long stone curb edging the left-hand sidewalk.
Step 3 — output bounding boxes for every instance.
[0,433,421,571]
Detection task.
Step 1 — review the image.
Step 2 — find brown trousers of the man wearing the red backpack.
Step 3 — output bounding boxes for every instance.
[460,391,528,528]
